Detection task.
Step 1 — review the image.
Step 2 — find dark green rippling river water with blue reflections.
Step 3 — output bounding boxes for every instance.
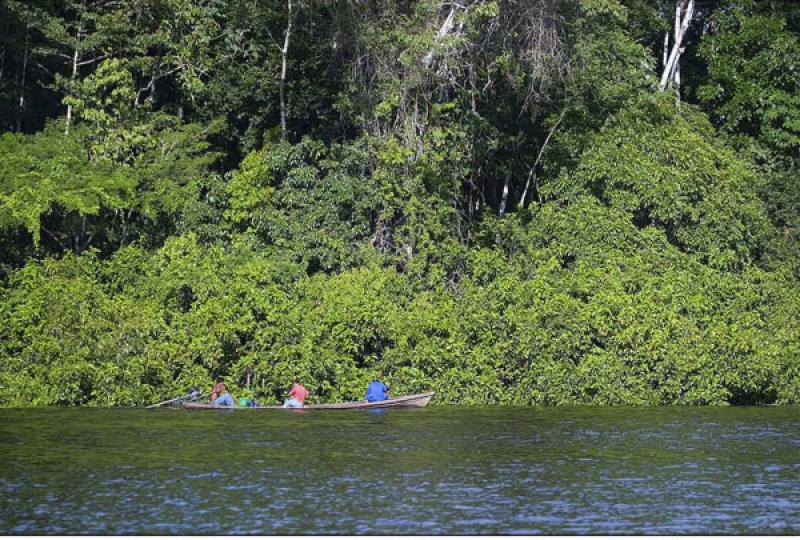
[0,407,800,534]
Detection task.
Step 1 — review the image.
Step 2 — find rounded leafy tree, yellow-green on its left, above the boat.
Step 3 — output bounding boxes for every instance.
[226,139,380,272]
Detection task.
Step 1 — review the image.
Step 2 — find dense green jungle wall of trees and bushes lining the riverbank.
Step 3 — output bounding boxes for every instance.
[0,0,800,406]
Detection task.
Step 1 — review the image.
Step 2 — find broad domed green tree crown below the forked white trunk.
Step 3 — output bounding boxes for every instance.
[548,97,770,267]
